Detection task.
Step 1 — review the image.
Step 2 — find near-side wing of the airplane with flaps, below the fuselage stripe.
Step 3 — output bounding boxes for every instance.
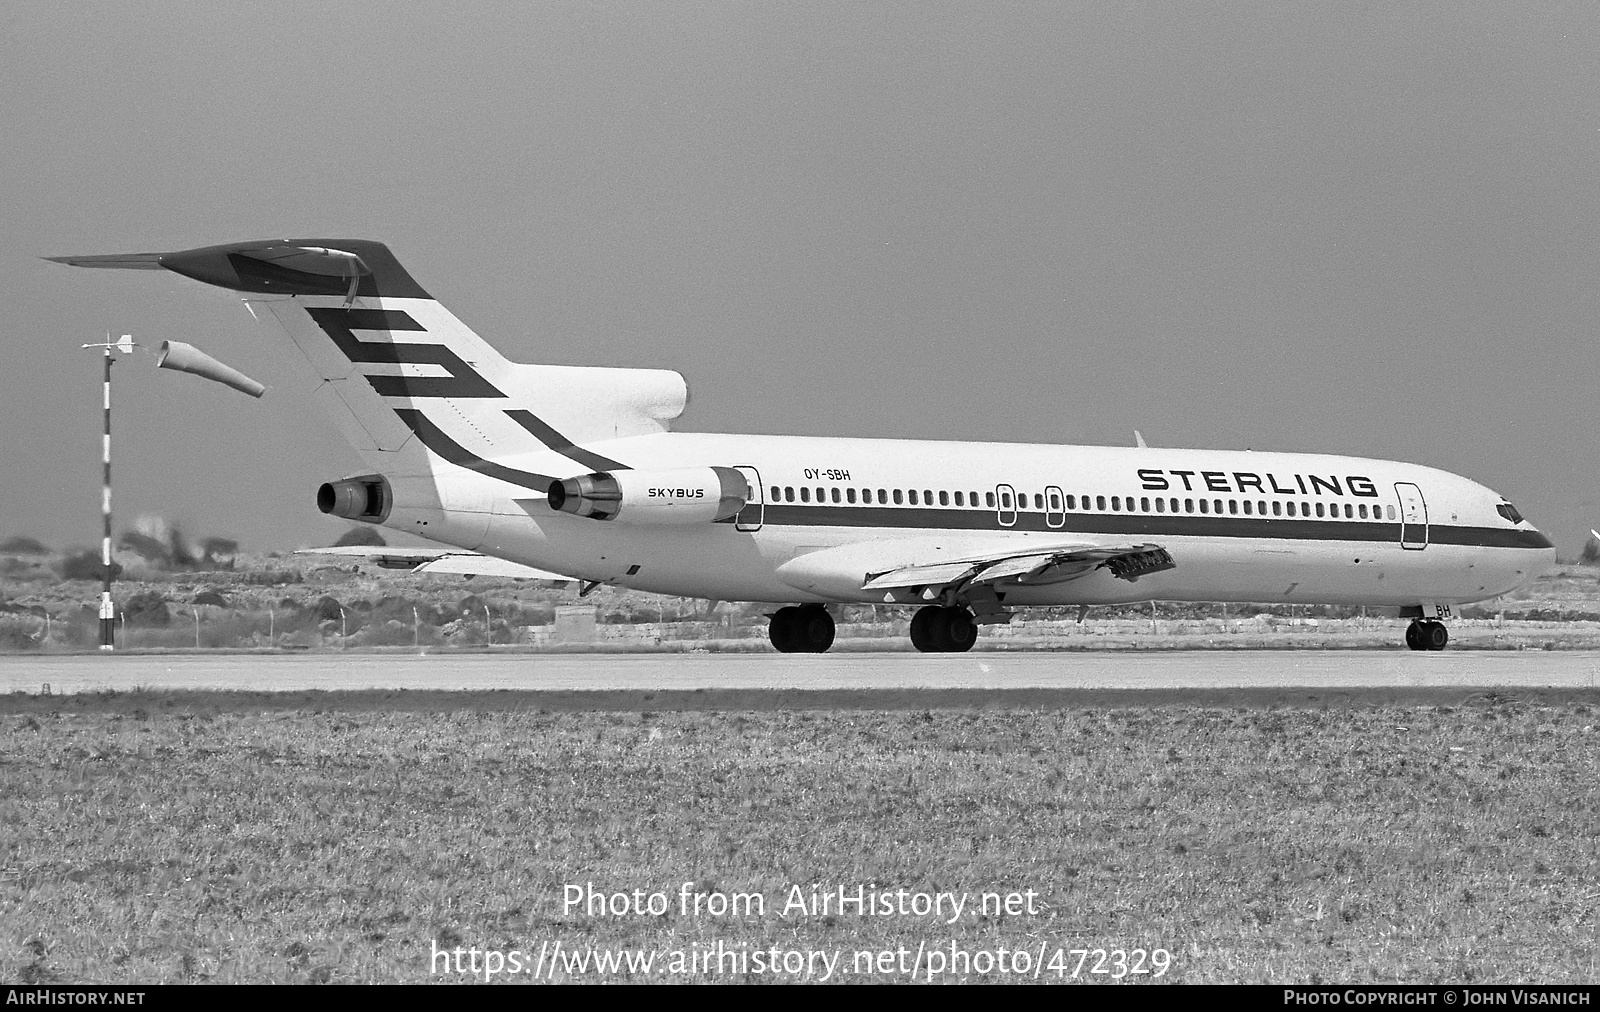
[861,544,1176,591]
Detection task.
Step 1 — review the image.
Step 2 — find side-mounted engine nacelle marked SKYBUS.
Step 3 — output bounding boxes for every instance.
[550,468,750,524]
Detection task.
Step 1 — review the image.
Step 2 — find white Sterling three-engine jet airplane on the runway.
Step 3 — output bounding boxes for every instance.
[46,239,1555,653]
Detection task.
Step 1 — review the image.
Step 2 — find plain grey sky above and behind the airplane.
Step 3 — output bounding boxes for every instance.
[0,0,1600,556]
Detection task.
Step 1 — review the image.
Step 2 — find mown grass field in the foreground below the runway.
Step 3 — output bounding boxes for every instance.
[0,695,1600,982]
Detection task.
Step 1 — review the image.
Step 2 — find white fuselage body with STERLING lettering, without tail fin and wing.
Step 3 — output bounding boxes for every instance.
[386,432,1554,605]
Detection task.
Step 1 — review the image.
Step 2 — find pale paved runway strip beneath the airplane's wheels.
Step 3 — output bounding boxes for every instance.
[0,650,1600,709]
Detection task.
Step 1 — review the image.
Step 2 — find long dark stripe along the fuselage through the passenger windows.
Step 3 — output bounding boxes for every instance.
[762,503,1550,548]
